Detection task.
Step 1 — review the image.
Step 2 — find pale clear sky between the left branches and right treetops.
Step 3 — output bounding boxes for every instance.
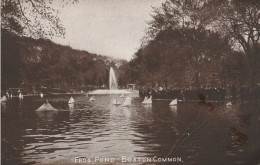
[52,0,164,60]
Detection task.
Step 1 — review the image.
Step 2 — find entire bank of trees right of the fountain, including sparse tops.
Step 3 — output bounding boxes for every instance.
[129,0,260,89]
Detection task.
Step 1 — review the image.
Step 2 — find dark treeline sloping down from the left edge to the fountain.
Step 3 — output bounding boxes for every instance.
[1,31,126,90]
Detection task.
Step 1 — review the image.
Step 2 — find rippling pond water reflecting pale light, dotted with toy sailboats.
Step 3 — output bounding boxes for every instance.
[1,95,260,165]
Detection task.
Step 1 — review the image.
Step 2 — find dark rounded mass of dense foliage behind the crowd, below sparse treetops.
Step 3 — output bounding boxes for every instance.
[129,29,244,88]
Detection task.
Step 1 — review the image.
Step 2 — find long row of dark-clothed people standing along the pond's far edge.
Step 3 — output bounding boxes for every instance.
[139,85,257,101]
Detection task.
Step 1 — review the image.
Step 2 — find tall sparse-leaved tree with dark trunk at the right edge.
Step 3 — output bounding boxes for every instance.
[205,0,260,84]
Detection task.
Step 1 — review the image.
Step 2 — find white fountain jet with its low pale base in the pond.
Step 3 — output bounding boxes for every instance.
[89,67,137,95]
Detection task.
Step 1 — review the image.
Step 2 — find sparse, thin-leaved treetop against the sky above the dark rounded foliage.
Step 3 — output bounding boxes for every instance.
[143,0,207,44]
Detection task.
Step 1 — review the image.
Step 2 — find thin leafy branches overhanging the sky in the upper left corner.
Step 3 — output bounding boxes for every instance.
[1,0,78,38]
